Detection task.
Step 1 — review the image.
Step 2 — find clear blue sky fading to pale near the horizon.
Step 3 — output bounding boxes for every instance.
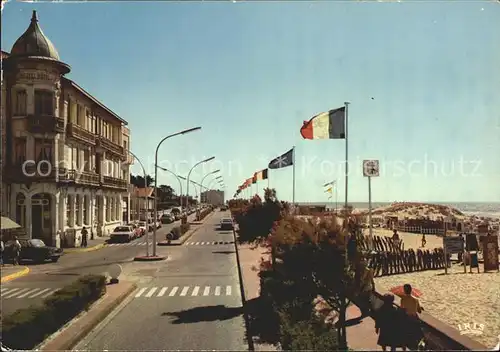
[1,1,500,202]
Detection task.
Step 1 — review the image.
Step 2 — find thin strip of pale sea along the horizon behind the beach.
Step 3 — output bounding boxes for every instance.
[299,201,500,218]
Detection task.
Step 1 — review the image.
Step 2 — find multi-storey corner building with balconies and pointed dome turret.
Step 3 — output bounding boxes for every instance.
[1,11,133,247]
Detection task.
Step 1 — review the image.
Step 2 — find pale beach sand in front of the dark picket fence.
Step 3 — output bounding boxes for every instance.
[375,265,500,349]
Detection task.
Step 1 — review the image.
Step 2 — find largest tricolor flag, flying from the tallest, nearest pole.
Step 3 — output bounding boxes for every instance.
[300,106,345,139]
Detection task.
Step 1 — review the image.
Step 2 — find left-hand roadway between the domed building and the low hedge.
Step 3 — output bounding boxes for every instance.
[1,218,188,315]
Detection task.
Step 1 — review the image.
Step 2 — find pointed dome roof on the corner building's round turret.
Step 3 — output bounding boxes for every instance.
[11,11,59,61]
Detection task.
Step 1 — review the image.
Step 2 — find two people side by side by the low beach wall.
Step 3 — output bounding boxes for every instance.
[375,284,423,351]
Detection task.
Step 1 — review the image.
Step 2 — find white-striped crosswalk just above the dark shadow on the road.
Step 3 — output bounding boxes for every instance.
[135,285,238,298]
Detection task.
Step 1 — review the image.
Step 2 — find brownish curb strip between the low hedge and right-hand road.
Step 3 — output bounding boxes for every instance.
[36,283,137,351]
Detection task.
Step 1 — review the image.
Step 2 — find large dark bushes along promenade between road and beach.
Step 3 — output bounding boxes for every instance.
[229,189,374,350]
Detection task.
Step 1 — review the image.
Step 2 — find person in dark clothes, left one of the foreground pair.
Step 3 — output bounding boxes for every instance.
[375,294,405,351]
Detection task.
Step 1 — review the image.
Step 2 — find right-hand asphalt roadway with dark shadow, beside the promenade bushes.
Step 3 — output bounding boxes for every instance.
[75,212,248,351]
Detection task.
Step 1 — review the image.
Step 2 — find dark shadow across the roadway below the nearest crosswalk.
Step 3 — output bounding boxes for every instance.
[161,305,243,324]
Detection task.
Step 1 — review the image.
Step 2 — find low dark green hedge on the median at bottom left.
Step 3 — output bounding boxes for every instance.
[2,275,106,350]
